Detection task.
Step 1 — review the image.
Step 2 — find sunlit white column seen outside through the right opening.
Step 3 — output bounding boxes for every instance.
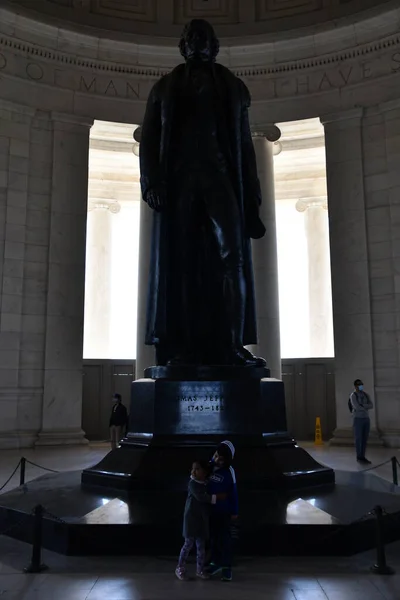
[296,197,333,357]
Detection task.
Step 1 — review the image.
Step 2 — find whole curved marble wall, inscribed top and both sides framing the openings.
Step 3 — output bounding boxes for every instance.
[0,0,400,446]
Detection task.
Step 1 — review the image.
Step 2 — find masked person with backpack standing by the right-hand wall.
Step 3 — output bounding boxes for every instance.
[349,379,374,465]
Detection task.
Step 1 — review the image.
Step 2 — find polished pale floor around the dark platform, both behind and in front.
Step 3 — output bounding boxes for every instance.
[0,444,400,600]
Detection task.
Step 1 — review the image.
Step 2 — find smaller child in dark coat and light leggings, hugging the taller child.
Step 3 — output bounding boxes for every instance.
[175,460,225,581]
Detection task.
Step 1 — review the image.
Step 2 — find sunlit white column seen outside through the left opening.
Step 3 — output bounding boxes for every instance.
[84,199,121,359]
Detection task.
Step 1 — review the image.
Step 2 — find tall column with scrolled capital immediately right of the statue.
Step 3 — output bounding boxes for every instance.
[250,125,281,379]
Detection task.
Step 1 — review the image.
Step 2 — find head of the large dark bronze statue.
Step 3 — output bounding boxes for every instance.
[179,19,219,62]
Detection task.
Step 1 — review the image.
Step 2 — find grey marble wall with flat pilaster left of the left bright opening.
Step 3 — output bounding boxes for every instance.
[0,101,89,447]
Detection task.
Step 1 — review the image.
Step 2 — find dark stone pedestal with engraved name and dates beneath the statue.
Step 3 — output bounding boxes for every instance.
[82,367,334,492]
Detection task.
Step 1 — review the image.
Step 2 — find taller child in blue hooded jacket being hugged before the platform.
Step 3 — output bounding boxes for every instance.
[207,440,238,581]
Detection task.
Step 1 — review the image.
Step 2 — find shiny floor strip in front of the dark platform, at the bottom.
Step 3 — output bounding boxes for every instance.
[0,537,400,600]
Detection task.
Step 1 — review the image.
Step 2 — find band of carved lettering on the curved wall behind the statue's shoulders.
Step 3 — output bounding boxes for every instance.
[0,48,400,100]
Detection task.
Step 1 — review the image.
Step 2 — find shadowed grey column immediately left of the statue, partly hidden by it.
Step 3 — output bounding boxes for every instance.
[133,127,155,379]
